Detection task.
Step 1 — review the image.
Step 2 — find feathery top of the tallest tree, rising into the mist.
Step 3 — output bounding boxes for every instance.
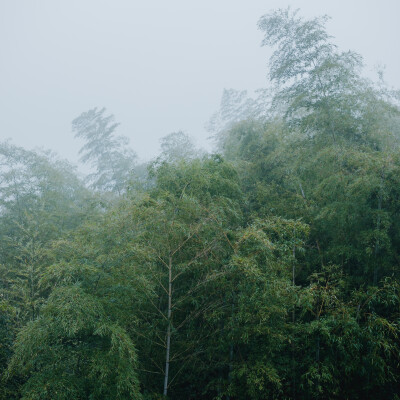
[258,8,393,143]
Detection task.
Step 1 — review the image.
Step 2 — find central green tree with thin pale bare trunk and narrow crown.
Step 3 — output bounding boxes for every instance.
[135,157,241,396]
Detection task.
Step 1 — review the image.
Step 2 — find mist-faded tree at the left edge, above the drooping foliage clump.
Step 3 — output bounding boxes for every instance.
[0,142,93,323]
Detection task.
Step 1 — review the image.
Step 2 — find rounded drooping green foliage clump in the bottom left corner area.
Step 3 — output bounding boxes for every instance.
[9,285,140,399]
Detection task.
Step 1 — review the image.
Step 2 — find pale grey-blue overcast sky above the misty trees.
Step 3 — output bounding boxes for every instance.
[0,0,400,166]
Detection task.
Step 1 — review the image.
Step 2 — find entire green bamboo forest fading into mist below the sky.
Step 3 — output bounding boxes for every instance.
[0,9,400,400]
